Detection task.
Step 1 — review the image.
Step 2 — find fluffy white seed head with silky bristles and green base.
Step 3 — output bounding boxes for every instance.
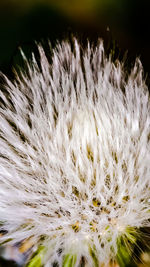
[0,40,150,267]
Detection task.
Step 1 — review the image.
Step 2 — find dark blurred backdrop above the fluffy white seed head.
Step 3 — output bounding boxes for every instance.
[0,0,150,81]
